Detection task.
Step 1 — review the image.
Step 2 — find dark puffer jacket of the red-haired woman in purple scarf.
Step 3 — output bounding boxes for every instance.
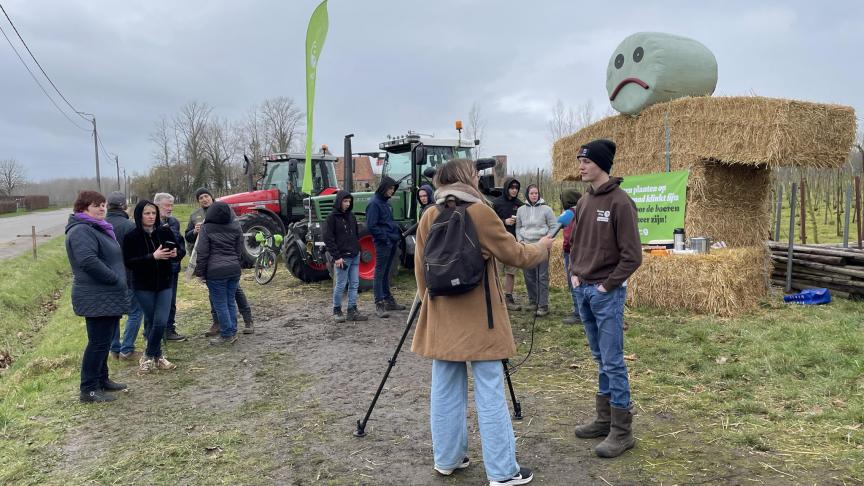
[66,216,129,317]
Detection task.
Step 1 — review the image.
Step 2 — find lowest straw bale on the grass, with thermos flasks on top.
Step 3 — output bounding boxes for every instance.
[627,245,771,317]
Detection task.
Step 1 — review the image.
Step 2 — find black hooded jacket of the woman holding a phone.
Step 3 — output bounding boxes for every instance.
[123,201,181,292]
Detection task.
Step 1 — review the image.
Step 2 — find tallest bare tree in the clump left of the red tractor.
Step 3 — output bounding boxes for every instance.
[174,101,213,190]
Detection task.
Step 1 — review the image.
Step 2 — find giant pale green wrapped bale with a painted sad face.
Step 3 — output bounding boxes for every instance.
[606,32,717,115]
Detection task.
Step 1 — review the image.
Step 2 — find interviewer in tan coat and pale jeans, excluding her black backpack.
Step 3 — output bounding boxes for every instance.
[411,159,553,486]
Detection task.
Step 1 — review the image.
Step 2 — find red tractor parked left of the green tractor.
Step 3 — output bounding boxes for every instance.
[219,152,338,282]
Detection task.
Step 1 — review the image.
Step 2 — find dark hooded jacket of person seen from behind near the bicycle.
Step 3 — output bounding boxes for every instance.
[195,201,243,280]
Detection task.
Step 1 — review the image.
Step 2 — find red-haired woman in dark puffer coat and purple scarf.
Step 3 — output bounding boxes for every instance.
[66,191,129,403]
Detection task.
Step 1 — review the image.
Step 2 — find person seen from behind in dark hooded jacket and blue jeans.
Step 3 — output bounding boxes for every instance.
[195,201,243,345]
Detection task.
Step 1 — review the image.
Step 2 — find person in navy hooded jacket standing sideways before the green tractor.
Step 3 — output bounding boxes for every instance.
[366,176,405,317]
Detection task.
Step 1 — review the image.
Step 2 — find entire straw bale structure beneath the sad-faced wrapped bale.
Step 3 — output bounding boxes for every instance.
[550,97,856,315]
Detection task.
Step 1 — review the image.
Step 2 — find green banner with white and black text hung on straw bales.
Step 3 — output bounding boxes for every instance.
[621,170,690,244]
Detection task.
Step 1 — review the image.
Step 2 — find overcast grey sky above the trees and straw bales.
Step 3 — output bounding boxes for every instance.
[0,0,864,180]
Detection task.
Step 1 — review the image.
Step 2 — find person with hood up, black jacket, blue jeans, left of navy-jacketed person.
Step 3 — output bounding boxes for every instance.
[324,190,367,322]
